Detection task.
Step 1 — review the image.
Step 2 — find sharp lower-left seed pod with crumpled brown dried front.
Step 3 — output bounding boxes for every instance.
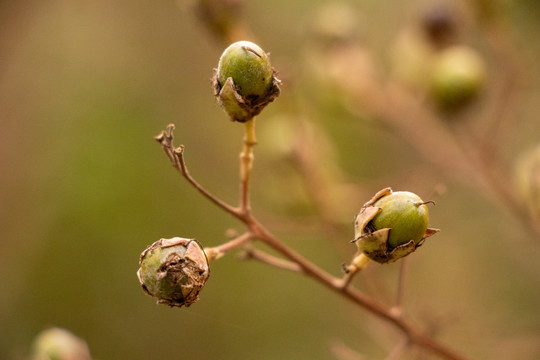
[137,237,210,307]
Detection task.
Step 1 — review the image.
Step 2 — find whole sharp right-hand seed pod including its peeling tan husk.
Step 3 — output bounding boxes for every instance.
[354,188,439,263]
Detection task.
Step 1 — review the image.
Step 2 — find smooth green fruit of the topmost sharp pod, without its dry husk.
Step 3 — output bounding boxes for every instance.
[217,41,273,97]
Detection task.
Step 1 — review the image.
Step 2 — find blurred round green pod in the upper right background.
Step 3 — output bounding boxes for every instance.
[430,46,486,109]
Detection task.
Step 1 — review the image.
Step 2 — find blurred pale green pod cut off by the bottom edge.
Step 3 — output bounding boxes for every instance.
[32,327,92,360]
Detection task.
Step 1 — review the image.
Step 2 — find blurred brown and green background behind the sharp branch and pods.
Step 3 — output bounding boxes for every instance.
[0,0,540,360]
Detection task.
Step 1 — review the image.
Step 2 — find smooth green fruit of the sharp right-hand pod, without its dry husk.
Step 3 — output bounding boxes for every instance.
[368,191,428,249]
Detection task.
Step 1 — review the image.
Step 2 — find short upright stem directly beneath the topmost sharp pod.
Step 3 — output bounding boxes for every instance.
[240,118,257,213]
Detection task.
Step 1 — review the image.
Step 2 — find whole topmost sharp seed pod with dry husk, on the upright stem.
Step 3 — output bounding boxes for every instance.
[212,41,280,122]
